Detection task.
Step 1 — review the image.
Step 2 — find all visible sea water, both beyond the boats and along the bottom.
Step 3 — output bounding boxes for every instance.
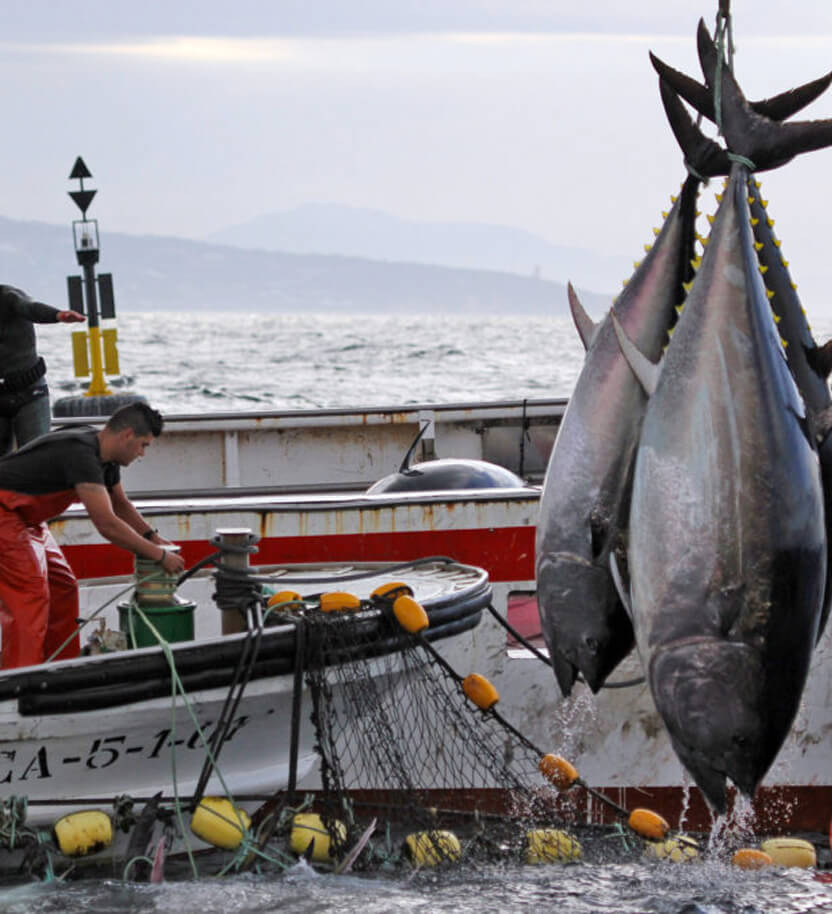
[11,312,832,914]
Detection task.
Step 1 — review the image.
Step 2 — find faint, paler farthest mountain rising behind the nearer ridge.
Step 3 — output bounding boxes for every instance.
[205,203,632,291]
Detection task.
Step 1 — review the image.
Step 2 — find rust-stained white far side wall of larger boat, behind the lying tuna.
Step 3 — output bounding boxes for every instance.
[50,399,566,497]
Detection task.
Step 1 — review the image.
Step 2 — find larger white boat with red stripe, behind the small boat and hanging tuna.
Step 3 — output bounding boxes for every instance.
[42,400,832,832]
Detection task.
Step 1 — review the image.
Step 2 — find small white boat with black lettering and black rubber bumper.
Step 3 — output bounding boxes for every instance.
[0,528,491,872]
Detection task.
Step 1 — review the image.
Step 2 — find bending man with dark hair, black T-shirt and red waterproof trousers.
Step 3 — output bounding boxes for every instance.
[0,402,185,669]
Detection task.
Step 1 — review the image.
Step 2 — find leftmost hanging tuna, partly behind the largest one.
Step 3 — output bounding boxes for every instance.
[536,178,699,695]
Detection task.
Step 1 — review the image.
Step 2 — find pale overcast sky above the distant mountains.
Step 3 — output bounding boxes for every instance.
[0,0,832,316]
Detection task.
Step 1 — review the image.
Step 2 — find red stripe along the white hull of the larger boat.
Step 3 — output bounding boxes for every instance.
[62,527,534,581]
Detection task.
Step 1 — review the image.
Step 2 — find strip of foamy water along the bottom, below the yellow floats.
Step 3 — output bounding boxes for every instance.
[0,863,832,914]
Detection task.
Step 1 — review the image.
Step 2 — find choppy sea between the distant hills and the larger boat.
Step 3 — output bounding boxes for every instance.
[37,312,583,414]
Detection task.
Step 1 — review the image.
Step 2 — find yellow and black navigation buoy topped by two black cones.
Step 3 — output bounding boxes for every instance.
[53,156,137,416]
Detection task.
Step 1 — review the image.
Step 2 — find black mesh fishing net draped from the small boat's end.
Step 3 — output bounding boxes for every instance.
[276,600,570,868]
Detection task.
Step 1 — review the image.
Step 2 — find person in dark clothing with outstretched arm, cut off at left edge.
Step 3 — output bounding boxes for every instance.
[0,285,85,456]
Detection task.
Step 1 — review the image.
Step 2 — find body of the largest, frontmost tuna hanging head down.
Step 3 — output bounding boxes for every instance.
[616,165,826,810]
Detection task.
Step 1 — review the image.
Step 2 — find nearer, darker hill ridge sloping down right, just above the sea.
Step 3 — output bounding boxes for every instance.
[0,217,609,315]
